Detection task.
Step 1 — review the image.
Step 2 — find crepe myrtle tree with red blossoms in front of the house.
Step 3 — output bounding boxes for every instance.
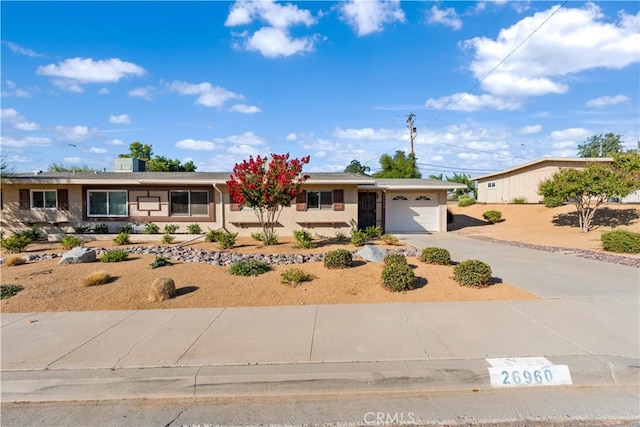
[226,153,310,245]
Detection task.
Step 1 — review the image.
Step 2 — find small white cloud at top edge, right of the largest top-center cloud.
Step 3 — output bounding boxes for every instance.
[339,0,406,36]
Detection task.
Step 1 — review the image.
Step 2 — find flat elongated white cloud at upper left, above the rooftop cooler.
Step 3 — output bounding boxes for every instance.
[36,58,146,92]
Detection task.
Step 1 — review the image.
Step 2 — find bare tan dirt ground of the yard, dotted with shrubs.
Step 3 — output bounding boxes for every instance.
[0,205,640,312]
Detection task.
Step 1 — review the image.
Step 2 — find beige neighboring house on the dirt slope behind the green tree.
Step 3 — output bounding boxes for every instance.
[472,157,640,203]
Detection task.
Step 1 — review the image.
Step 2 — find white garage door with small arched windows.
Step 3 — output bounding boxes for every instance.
[386,193,438,233]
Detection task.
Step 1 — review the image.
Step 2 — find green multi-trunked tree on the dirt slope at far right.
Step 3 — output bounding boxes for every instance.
[538,164,638,233]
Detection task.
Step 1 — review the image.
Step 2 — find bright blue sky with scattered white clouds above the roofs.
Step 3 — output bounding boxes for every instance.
[0,0,640,177]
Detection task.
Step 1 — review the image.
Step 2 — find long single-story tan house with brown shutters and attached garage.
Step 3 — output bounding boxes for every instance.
[0,172,466,236]
